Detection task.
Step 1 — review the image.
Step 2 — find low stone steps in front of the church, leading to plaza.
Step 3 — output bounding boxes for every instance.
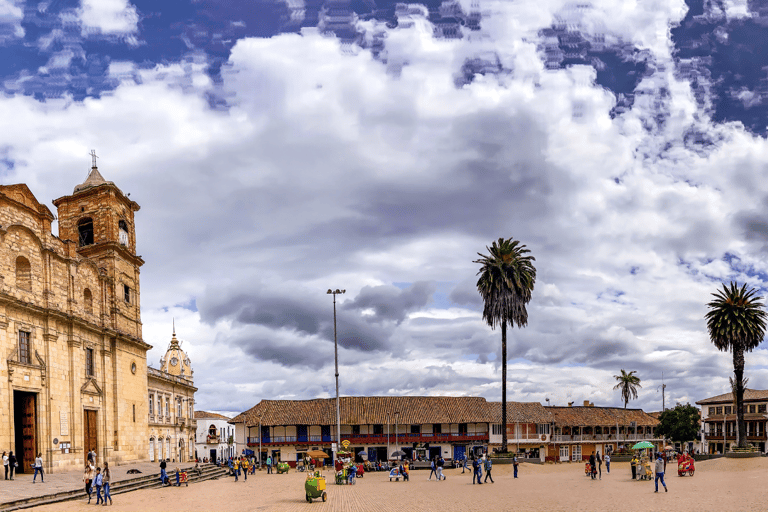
[0,464,229,512]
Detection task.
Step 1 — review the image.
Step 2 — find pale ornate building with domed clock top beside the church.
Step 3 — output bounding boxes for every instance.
[147,327,197,462]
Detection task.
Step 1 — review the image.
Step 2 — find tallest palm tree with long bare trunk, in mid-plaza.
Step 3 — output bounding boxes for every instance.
[473,238,536,452]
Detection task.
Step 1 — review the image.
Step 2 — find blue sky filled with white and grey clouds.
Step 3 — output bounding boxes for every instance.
[0,0,768,414]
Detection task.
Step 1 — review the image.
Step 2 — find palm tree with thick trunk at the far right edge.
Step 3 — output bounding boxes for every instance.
[705,282,766,448]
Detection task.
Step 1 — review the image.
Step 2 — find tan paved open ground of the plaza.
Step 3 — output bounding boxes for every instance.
[13,458,768,512]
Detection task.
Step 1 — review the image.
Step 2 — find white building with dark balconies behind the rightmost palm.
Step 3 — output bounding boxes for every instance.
[696,389,768,453]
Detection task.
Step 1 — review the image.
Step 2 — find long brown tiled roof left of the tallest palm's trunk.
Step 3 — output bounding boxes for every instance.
[230,396,494,426]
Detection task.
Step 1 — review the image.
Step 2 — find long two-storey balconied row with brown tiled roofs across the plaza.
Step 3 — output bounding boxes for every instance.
[230,397,663,463]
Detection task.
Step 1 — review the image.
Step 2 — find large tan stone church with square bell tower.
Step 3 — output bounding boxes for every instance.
[0,159,167,471]
